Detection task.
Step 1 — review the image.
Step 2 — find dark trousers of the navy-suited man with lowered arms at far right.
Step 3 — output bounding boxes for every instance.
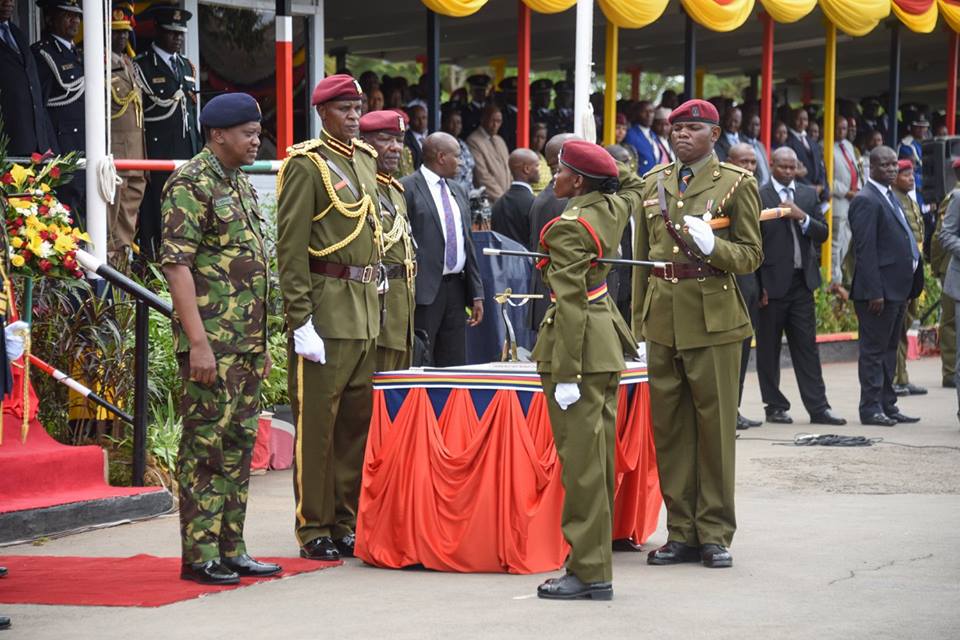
[853,300,907,419]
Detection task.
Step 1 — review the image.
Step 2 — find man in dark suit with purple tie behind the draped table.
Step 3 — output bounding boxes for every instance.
[402,132,483,367]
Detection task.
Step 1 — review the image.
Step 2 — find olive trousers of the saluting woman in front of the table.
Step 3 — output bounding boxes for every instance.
[540,371,620,582]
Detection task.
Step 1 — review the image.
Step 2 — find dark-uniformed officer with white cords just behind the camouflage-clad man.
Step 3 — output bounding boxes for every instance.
[134,6,200,259]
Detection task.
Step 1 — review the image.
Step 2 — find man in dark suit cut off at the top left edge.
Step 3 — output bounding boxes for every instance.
[0,0,59,156]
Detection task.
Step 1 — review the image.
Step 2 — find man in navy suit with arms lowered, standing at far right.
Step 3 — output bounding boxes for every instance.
[849,145,923,427]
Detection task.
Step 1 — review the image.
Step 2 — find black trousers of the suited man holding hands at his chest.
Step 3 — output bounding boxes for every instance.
[757,269,832,416]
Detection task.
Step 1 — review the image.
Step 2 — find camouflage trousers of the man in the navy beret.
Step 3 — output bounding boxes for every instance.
[177,353,266,563]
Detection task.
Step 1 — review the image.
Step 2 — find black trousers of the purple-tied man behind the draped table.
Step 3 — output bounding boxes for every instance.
[413,273,472,367]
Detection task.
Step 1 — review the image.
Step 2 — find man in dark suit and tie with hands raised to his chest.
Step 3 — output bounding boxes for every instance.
[757,147,847,426]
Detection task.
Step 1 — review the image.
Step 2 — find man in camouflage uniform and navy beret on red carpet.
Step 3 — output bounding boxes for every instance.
[160,93,280,584]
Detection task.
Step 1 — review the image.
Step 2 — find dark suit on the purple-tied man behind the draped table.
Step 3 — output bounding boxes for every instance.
[401,166,483,367]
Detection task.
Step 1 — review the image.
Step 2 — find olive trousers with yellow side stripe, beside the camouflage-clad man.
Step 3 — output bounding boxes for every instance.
[288,338,376,546]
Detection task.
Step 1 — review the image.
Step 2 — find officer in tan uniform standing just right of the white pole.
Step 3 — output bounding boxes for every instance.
[107,2,147,266]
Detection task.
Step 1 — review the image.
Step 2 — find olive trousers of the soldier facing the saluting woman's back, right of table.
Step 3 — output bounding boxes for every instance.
[647,341,740,547]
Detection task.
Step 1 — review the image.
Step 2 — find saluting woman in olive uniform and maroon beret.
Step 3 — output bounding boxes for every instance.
[532,140,642,600]
